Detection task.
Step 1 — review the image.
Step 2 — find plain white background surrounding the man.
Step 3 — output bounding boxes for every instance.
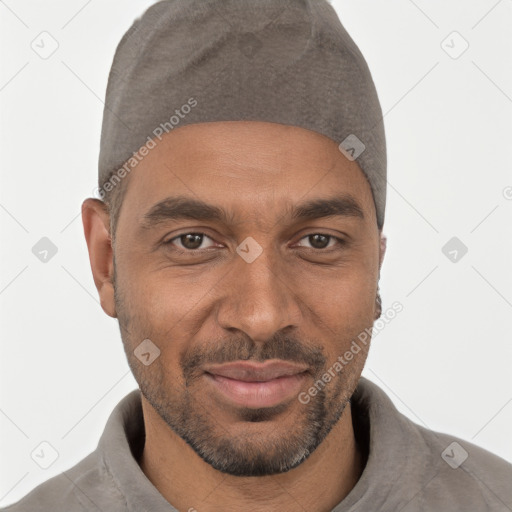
[0,0,512,506]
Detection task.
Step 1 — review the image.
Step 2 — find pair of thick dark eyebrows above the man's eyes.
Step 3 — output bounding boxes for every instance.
[141,194,364,229]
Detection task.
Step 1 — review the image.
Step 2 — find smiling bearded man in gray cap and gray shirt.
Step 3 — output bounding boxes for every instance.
[5,0,512,512]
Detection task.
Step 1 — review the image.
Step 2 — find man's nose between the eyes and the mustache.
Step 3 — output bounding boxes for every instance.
[217,244,302,342]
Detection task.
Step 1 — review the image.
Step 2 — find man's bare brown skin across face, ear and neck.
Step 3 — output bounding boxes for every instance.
[82,121,386,512]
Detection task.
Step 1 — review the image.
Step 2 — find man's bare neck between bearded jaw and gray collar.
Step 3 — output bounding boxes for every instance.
[139,396,366,512]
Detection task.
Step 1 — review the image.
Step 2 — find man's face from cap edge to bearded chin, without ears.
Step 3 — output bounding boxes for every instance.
[106,122,380,476]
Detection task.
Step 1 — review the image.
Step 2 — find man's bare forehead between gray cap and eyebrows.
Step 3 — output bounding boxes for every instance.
[123,121,374,225]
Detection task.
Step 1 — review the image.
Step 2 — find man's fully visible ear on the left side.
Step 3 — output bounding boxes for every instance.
[82,197,117,318]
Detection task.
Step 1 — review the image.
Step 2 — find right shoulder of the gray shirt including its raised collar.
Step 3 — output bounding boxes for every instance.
[353,377,512,512]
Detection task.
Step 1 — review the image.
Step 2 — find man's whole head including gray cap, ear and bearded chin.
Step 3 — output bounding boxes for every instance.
[82,0,386,476]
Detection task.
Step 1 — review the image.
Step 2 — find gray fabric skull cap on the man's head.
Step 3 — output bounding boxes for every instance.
[98,0,386,229]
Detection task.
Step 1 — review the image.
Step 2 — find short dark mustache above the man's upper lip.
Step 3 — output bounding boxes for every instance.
[180,333,327,377]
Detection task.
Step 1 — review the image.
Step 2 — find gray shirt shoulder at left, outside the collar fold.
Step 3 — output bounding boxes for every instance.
[0,452,126,512]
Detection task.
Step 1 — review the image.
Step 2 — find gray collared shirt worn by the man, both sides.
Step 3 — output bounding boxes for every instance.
[1,377,512,512]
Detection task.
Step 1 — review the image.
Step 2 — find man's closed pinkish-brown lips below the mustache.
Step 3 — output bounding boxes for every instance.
[205,361,308,408]
